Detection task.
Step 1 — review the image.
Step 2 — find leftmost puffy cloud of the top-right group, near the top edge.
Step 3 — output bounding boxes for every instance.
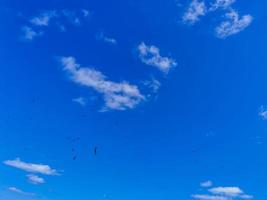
[183,0,207,24]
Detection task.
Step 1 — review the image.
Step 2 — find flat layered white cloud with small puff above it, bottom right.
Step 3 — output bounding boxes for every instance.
[191,181,253,200]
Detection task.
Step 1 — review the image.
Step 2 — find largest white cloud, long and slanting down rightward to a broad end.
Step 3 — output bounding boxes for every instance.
[60,57,145,110]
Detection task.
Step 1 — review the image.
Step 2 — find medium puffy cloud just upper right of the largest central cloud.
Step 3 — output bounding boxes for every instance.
[138,42,177,73]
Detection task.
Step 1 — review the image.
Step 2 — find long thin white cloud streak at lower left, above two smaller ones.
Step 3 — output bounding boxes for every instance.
[4,158,59,176]
